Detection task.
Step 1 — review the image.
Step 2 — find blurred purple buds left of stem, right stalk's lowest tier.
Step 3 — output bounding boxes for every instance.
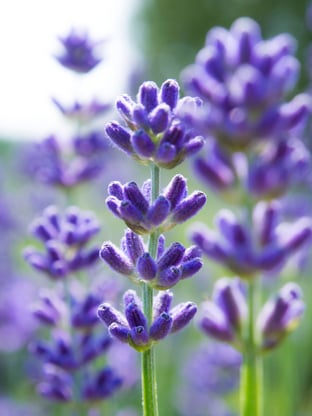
[199,278,247,348]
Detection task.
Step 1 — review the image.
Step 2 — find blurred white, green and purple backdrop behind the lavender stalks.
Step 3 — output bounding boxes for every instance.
[0,0,312,416]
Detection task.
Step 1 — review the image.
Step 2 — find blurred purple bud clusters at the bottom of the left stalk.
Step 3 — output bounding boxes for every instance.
[30,284,130,401]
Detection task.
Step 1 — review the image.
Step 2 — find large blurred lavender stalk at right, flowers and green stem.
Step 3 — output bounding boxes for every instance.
[179,18,312,416]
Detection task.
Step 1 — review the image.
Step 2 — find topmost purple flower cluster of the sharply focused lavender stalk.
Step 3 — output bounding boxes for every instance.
[105,79,203,169]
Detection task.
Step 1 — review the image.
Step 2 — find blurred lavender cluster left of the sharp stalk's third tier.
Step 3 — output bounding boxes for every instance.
[24,206,99,279]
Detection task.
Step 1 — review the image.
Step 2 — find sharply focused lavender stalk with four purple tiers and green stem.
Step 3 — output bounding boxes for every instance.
[99,80,206,416]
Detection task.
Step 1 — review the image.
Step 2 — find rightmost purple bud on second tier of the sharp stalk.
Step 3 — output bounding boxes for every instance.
[171,191,206,224]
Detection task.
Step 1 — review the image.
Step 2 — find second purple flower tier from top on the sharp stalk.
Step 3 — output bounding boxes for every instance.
[106,175,206,234]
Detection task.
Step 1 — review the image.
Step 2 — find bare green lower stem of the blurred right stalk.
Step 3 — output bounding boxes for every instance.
[240,279,262,416]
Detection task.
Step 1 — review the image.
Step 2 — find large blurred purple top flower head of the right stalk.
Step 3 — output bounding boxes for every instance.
[180,17,311,152]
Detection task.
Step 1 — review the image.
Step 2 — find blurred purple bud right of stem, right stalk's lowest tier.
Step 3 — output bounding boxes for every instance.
[257,283,305,350]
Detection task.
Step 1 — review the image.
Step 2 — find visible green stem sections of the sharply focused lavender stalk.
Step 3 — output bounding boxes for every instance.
[141,164,160,416]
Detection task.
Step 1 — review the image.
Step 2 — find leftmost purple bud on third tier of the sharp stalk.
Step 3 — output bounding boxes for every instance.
[99,241,133,276]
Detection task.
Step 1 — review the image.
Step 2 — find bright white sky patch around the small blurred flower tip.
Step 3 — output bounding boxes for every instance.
[0,0,137,140]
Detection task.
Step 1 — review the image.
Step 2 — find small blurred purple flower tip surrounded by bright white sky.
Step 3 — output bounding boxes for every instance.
[55,29,103,74]
